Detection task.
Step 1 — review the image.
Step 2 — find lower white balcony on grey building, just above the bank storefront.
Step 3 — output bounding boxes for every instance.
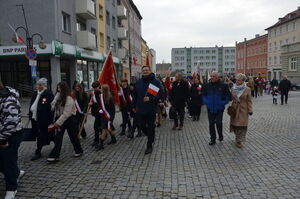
[77,30,96,50]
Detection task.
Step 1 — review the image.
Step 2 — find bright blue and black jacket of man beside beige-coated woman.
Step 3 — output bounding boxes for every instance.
[202,81,231,113]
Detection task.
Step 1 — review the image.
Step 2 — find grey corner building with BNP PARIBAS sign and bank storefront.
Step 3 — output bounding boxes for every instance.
[0,0,119,92]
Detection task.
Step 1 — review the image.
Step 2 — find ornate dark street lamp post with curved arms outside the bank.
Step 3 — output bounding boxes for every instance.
[12,4,47,85]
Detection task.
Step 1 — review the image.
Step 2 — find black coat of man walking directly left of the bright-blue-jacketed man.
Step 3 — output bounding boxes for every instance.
[170,80,189,108]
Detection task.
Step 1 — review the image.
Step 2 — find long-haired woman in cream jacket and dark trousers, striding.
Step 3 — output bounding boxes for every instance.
[47,82,83,162]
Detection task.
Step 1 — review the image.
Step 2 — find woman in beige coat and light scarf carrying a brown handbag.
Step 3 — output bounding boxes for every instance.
[230,74,252,148]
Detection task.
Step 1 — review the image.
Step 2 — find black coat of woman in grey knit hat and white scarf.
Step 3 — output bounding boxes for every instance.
[29,90,54,125]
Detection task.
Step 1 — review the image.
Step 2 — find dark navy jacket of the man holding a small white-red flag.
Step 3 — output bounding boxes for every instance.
[133,73,162,115]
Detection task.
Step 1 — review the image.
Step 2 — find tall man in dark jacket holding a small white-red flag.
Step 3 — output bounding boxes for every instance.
[133,66,161,154]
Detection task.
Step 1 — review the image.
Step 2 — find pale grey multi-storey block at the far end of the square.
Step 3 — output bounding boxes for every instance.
[171,46,235,75]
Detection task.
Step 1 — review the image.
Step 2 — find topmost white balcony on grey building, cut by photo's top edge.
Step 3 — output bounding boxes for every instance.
[75,0,96,20]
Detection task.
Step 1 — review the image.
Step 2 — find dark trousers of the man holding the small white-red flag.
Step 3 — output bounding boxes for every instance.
[137,114,156,145]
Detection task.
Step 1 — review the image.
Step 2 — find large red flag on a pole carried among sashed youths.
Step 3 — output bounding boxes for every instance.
[98,51,120,106]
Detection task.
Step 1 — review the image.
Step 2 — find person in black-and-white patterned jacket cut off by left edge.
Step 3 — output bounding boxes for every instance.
[0,79,24,199]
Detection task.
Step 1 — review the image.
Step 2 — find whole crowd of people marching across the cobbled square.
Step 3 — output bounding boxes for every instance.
[0,66,291,199]
